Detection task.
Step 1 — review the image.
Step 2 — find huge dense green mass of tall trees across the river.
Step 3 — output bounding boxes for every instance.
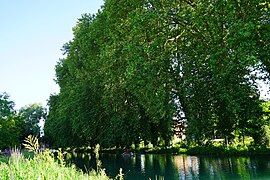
[45,0,270,147]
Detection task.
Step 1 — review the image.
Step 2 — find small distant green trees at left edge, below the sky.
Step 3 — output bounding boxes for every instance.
[0,93,47,150]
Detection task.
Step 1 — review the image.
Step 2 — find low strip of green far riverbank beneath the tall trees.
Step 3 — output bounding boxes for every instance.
[47,142,270,156]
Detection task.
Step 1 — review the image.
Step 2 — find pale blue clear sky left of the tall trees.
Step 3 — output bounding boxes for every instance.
[0,0,104,109]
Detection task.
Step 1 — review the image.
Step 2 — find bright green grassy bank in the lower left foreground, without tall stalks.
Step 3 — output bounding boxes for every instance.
[0,151,113,180]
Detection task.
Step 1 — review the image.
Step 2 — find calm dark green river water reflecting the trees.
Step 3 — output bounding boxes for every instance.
[67,154,270,180]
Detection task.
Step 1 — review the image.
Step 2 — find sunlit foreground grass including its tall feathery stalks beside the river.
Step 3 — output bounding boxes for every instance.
[0,135,118,180]
